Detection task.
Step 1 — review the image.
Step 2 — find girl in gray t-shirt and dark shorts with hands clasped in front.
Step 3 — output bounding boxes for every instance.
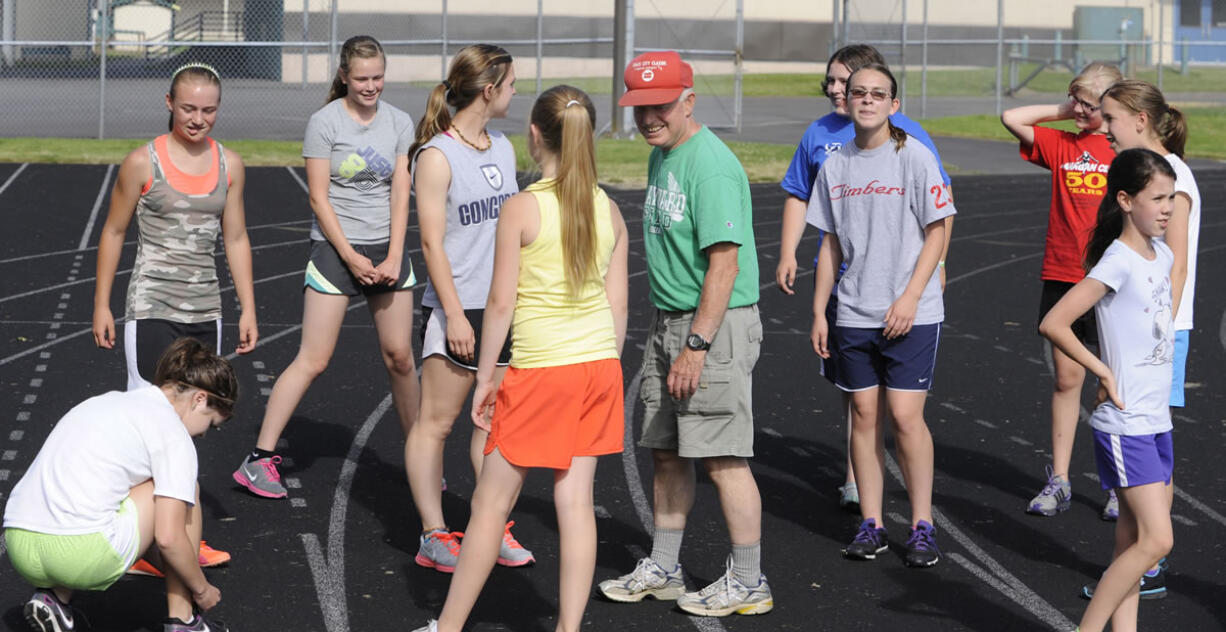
[234,36,418,498]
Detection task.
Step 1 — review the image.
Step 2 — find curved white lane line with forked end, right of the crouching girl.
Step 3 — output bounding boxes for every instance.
[302,394,391,632]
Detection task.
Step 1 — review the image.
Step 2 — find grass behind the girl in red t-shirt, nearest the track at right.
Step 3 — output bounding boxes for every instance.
[921,108,1226,160]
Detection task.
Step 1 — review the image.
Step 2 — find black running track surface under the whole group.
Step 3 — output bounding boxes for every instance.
[0,164,1226,632]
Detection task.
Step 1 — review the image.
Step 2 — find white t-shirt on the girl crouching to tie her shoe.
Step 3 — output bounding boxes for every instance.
[4,387,196,535]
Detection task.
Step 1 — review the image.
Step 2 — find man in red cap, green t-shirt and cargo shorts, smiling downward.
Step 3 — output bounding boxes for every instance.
[590,52,774,616]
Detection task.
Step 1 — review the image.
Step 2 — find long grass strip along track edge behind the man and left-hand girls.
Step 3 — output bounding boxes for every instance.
[0,135,794,187]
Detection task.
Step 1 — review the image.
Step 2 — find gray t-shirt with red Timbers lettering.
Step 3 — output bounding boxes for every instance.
[805,136,956,329]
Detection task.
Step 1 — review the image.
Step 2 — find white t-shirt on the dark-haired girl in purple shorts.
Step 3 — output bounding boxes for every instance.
[1086,239,1175,434]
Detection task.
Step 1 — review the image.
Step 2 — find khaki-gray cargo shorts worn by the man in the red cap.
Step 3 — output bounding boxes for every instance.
[639,304,763,459]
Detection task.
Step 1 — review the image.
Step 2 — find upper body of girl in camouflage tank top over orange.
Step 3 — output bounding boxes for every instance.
[93,64,259,383]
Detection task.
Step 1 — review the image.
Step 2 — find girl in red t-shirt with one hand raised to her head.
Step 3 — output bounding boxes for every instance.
[1000,63,1123,520]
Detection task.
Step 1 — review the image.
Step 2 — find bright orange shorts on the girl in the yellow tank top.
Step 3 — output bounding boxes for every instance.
[485,358,625,470]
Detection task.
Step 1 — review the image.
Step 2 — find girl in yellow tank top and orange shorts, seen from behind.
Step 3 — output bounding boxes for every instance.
[418,86,628,632]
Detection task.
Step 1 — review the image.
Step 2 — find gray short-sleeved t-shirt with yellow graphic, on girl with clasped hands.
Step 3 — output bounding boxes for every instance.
[303,98,413,244]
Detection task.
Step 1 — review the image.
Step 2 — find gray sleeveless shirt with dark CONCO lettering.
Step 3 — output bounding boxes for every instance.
[413,130,520,309]
